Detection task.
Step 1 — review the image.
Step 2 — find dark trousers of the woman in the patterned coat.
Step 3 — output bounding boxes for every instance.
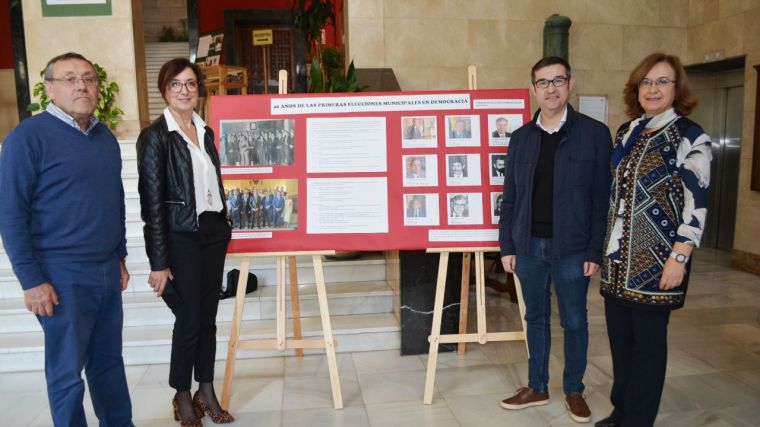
[604,298,670,427]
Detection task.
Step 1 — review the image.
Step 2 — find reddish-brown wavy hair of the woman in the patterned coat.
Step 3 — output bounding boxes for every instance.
[623,52,697,119]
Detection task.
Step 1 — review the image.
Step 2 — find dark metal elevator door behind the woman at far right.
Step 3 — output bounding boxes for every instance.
[703,72,744,250]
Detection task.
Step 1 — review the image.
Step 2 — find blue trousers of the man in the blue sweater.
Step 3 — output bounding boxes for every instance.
[37,258,133,427]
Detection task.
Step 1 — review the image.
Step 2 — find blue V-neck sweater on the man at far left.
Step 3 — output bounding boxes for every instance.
[0,112,127,289]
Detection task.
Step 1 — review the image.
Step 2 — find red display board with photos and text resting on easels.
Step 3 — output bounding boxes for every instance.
[209,89,530,252]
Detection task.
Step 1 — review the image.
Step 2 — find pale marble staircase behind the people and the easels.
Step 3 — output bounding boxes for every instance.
[0,139,401,372]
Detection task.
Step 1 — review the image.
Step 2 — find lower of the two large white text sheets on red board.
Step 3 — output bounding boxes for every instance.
[306,178,388,234]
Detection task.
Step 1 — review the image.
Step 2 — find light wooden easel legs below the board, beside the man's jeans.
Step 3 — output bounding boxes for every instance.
[423,247,528,405]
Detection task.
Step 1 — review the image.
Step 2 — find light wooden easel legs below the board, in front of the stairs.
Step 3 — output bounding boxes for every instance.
[221,251,343,409]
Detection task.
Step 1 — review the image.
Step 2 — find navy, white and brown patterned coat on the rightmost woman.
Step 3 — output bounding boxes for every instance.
[601,110,712,310]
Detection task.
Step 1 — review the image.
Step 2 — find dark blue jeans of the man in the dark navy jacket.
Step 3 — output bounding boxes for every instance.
[515,237,589,393]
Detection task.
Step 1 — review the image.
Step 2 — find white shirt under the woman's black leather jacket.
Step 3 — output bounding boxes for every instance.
[164,107,224,216]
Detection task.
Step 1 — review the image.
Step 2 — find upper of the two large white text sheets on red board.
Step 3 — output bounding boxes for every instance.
[306,117,387,173]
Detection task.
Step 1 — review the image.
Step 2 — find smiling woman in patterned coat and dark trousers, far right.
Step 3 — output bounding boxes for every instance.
[596,53,712,427]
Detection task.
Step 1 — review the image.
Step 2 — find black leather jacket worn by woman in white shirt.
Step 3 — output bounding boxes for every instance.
[137,115,227,271]
